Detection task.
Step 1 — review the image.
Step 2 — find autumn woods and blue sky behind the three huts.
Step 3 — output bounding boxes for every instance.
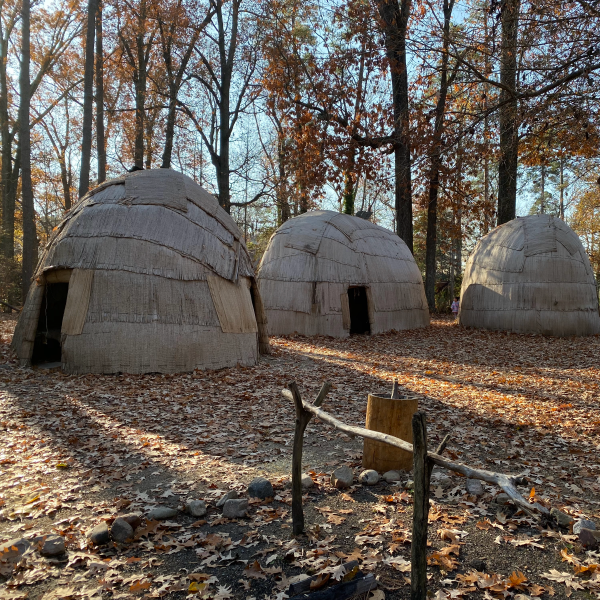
[0,0,600,309]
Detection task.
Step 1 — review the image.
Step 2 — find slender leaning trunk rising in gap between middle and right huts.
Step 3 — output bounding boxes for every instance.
[425,0,454,311]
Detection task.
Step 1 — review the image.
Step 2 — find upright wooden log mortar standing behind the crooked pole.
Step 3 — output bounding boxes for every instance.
[363,394,419,473]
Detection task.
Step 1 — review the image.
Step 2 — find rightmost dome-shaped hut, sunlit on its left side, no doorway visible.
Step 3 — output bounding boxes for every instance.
[459,215,600,336]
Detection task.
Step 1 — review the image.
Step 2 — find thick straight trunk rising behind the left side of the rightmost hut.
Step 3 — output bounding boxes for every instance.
[498,0,521,225]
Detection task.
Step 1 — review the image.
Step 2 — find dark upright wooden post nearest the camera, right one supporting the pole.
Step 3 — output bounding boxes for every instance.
[410,412,431,600]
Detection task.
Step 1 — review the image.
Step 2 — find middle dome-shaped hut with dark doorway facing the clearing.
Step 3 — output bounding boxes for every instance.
[258,210,429,337]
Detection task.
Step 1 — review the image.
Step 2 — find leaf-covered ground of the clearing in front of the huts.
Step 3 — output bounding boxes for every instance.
[0,317,600,600]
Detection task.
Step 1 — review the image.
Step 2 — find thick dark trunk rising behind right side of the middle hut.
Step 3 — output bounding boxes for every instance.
[377,0,413,252]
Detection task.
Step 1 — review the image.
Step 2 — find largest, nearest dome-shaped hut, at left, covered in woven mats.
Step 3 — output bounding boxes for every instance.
[13,169,268,373]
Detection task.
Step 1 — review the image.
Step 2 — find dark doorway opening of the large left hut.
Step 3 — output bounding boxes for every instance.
[31,283,69,365]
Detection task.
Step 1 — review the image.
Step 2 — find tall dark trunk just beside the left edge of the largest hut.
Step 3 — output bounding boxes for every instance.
[19,0,37,299]
